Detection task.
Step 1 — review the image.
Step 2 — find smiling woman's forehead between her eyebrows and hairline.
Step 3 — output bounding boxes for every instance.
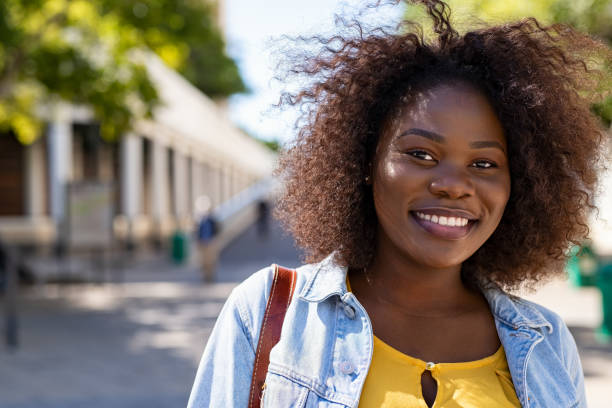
[381,83,506,145]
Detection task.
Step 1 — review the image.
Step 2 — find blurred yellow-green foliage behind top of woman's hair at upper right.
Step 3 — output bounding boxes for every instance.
[406,0,612,126]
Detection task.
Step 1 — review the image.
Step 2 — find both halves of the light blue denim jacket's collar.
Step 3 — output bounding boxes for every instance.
[299,253,553,333]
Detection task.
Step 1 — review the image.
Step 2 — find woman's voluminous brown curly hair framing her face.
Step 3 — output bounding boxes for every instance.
[275,0,610,290]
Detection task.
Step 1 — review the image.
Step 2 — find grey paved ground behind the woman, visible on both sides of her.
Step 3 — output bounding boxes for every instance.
[0,222,612,408]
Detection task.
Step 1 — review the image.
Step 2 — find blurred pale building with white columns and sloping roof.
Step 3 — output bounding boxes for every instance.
[0,51,275,252]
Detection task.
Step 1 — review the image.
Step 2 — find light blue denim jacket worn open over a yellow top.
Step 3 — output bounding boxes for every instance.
[188,256,586,408]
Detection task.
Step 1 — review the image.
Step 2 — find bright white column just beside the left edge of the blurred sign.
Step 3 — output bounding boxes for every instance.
[47,107,72,223]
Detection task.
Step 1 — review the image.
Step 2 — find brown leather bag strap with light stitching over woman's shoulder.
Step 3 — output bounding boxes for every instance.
[249,265,296,408]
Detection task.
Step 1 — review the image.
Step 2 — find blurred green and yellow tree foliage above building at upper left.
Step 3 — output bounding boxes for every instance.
[0,0,245,143]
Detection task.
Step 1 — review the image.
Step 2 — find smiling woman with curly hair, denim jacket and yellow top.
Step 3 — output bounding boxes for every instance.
[189,1,610,408]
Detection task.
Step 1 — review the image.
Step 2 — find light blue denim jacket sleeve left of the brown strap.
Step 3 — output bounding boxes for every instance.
[187,270,268,408]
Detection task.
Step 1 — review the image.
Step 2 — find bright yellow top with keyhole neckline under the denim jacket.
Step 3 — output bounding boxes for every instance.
[347,278,521,408]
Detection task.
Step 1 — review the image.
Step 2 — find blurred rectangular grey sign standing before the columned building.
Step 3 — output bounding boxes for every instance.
[67,182,114,249]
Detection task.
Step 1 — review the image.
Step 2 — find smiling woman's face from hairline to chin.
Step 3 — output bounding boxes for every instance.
[372,83,510,268]
